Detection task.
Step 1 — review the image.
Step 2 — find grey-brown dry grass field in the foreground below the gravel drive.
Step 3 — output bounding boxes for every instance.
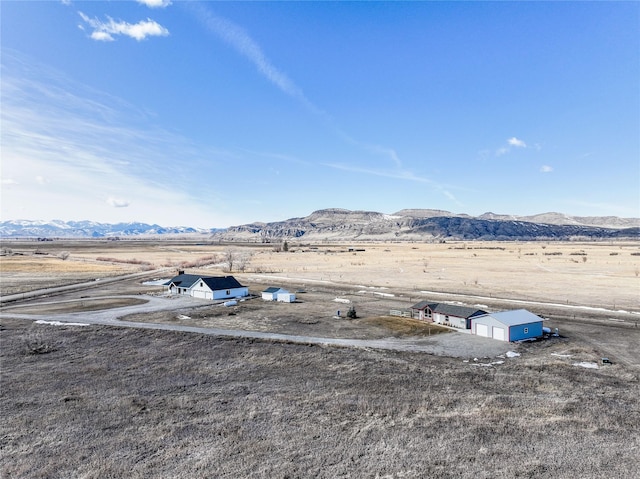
[0,320,640,479]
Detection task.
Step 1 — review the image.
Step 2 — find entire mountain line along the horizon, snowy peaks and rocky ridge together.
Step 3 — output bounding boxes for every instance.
[0,208,640,243]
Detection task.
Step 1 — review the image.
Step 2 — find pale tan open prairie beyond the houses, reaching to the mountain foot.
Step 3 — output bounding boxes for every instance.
[0,240,640,311]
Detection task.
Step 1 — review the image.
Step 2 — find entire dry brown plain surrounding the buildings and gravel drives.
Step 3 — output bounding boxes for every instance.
[0,241,640,478]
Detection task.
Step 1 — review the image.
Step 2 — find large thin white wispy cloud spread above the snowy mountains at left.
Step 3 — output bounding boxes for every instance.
[0,50,230,226]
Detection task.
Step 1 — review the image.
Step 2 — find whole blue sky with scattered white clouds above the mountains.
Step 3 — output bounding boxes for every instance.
[0,0,640,227]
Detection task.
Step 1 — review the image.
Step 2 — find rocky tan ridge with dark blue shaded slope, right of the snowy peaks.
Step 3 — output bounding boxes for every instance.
[213,208,640,242]
